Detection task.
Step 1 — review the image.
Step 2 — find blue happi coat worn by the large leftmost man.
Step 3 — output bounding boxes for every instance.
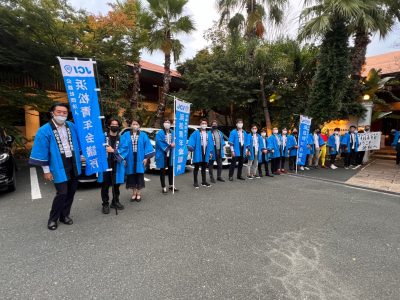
[29,121,82,183]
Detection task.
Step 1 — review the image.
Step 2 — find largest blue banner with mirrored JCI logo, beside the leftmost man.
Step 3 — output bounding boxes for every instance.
[58,58,108,175]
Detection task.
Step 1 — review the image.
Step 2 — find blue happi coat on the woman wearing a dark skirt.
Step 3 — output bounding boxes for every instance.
[118,130,155,175]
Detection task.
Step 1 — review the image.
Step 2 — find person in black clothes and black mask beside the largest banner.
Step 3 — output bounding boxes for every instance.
[97,118,125,214]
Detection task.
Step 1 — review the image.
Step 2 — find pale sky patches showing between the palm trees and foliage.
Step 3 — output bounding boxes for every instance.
[69,0,400,65]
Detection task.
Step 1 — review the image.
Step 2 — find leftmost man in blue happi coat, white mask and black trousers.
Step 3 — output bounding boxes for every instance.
[29,103,81,230]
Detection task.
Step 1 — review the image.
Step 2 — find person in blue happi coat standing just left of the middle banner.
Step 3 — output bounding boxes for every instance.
[156,119,178,194]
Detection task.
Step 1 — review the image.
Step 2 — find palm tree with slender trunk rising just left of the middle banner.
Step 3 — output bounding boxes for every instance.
[145,0,195,127]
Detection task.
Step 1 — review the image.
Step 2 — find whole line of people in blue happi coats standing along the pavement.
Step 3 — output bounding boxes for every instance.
[30,103,400,230]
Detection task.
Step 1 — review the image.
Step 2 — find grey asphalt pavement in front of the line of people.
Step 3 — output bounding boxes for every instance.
[0,164,400,299]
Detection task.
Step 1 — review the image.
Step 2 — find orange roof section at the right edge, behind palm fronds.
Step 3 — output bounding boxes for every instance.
[362,51,400,77]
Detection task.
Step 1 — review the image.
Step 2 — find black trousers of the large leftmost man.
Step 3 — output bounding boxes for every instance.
[49,158,78,222]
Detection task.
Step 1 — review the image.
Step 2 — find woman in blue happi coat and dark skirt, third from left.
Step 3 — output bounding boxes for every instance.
[118,119,155,202]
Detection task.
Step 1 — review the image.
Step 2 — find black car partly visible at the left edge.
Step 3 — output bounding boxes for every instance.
[0,127,17,192]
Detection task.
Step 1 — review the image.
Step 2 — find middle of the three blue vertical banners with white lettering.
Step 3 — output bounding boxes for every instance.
[174,98,191,176]
